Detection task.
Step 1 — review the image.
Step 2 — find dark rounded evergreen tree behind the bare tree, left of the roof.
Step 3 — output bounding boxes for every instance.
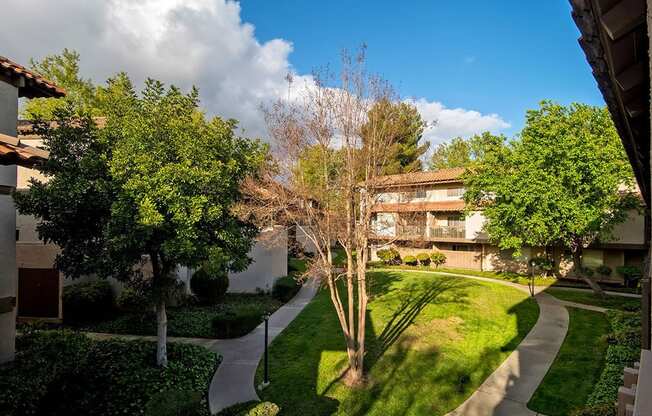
[361,99,430,175]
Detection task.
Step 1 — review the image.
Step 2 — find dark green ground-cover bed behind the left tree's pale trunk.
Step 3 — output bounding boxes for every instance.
[75,293,283,338]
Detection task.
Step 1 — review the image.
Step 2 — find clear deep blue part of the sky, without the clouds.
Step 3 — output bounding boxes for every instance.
[240,0,604,135]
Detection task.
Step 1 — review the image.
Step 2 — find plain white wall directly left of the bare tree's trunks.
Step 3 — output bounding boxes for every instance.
[229,227,288,293]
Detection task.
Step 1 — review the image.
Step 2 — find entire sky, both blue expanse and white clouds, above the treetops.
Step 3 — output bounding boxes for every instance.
[0,0,604,150]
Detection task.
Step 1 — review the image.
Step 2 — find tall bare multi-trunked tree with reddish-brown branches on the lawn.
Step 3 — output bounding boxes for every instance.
[253,48,404,384]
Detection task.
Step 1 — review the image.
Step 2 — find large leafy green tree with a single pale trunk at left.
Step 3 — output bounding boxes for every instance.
[15,74,265,366]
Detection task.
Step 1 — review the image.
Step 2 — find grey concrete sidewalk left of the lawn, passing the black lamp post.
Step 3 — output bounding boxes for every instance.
[208,279,319,414]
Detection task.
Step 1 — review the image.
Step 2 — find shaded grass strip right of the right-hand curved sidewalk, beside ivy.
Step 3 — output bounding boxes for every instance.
[528,308,610,416]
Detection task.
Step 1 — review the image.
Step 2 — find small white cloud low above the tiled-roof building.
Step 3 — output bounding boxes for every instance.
[407,98,511,148]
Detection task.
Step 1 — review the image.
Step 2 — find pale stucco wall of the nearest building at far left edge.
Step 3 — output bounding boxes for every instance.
[0,81,18,363]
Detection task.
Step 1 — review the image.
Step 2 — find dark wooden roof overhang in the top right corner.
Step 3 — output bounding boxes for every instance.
[570,0,652,208]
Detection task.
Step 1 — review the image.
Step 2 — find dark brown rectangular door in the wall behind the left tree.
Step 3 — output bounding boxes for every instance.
[18,268,59,318]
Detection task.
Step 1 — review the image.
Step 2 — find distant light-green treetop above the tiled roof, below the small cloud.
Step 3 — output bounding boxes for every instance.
[430,131,505,170]
